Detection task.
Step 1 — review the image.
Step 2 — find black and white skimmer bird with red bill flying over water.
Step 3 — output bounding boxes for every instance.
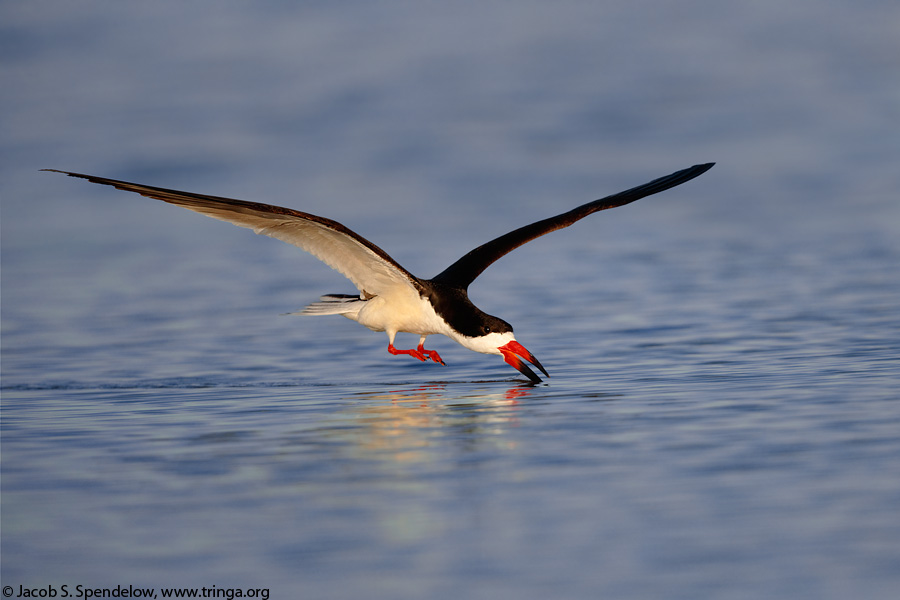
[42,163,715,385]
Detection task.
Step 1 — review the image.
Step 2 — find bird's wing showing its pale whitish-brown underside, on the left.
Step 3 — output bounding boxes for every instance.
[43,169,421,296]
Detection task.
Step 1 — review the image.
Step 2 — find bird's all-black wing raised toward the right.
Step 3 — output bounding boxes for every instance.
[431,163,716,289]
